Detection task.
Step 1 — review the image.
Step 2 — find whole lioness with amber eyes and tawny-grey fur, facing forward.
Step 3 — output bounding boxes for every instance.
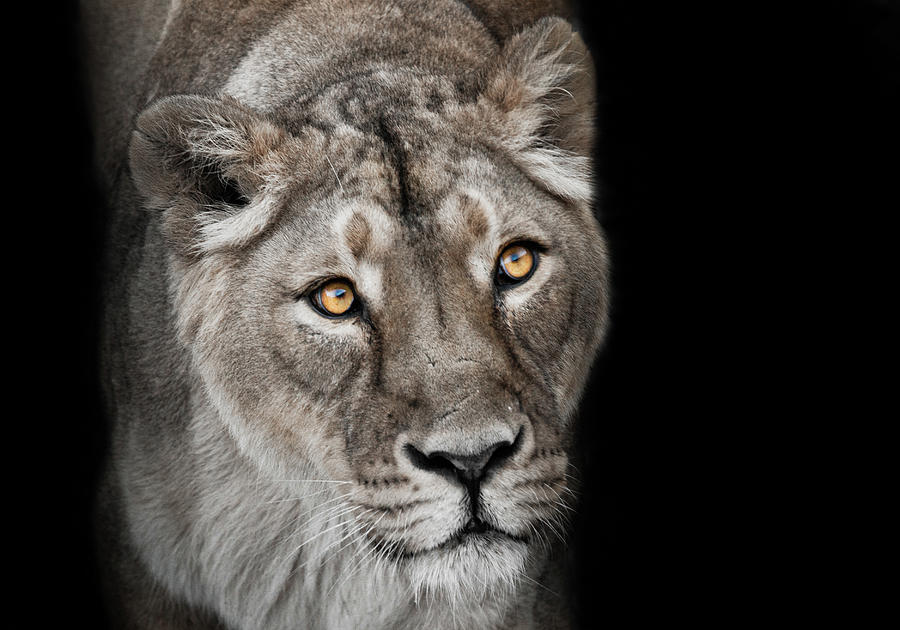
[83,0,608,630]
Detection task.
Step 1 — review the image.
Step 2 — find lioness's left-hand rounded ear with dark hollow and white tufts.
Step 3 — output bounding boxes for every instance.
[129,96,287,256]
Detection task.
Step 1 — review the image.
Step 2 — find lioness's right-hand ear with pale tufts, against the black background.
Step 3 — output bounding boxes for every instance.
[483,18,596,201]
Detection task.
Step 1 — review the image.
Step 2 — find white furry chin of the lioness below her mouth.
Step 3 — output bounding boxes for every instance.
[406,531,529,601]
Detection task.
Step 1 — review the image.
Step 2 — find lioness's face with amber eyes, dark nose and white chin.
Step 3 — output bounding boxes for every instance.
[132,19,607,604]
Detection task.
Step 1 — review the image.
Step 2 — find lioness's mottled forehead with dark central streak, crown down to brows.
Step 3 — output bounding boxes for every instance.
[253,71,565,264]
